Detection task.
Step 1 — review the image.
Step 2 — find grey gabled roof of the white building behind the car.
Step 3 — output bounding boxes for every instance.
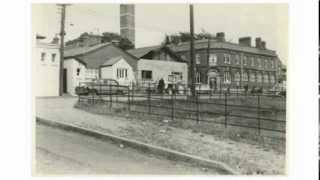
[65,43,138,69]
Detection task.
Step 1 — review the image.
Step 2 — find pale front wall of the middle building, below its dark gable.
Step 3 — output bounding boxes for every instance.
[137,59,188,85]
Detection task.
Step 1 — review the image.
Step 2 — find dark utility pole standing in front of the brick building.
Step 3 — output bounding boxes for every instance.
[189,4,196,97]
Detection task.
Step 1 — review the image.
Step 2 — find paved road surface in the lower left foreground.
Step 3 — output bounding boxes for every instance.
[35,124,217,175]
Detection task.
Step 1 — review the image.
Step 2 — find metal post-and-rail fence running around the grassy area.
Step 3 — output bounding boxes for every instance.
[79,85,286,138]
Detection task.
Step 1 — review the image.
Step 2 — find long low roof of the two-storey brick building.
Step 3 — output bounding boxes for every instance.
[168,40,277,56]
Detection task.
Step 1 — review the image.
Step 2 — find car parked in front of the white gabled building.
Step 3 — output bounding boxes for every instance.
[75,79,128,95]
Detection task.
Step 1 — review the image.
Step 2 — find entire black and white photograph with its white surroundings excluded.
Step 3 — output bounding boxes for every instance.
[31,3,290,176]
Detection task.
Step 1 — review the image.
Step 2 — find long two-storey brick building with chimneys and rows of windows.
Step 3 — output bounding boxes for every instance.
[169,33,281,89]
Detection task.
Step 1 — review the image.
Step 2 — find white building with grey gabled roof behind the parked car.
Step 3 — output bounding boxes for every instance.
[64,43,138,95]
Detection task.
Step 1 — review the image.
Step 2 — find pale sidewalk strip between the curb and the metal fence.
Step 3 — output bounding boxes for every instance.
[36,97,285,175]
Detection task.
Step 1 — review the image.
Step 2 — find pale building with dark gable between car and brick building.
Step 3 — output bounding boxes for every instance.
[128,45,188,88]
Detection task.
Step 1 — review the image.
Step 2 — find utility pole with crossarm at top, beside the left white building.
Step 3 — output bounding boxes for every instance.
[57,4,69,96]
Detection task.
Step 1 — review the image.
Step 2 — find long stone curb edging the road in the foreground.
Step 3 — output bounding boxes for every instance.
[36,117,239,175]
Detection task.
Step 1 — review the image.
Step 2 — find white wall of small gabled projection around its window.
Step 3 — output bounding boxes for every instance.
[101,59,135,86]
